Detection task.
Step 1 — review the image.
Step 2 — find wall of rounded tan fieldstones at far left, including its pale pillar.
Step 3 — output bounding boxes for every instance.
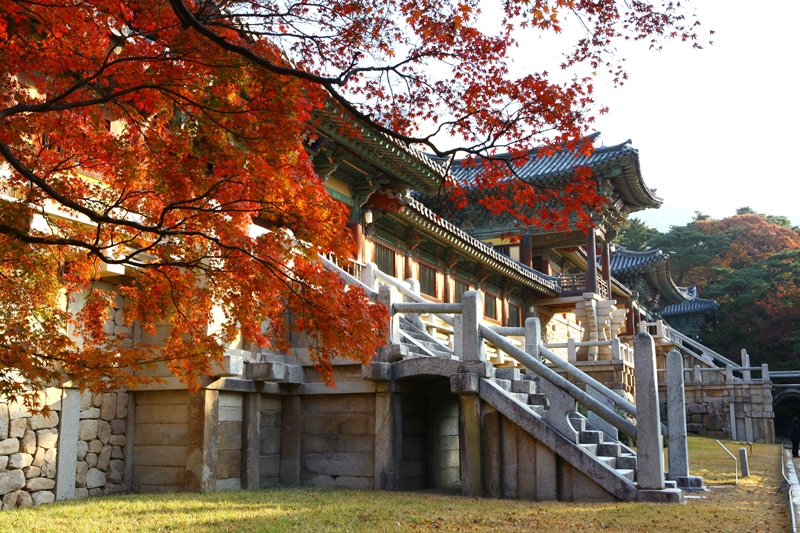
[0,388,129,509]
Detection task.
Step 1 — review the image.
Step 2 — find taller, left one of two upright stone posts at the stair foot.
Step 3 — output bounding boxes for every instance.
[633,332,664,490]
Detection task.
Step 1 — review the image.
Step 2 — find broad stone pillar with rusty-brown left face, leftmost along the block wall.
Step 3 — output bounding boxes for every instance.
[184,389,219,492]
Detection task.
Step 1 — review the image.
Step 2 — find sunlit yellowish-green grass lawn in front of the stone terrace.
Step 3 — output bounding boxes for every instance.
[0,438,790,533]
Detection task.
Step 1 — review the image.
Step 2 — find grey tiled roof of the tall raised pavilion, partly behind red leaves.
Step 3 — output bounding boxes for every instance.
[451,133,664,210]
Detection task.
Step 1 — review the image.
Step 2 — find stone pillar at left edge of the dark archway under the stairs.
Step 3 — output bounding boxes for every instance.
[375,392,400,490]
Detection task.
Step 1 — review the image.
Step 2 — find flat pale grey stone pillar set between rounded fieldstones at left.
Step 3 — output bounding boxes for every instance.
[55,389,80,500]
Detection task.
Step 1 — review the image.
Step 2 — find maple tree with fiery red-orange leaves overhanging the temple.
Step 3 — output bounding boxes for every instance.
[0,0,712,401]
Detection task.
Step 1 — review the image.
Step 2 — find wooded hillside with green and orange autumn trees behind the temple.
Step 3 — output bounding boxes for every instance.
[617,207,800,369]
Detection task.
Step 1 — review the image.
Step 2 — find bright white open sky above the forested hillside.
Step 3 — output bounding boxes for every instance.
[500,0,800,231]
